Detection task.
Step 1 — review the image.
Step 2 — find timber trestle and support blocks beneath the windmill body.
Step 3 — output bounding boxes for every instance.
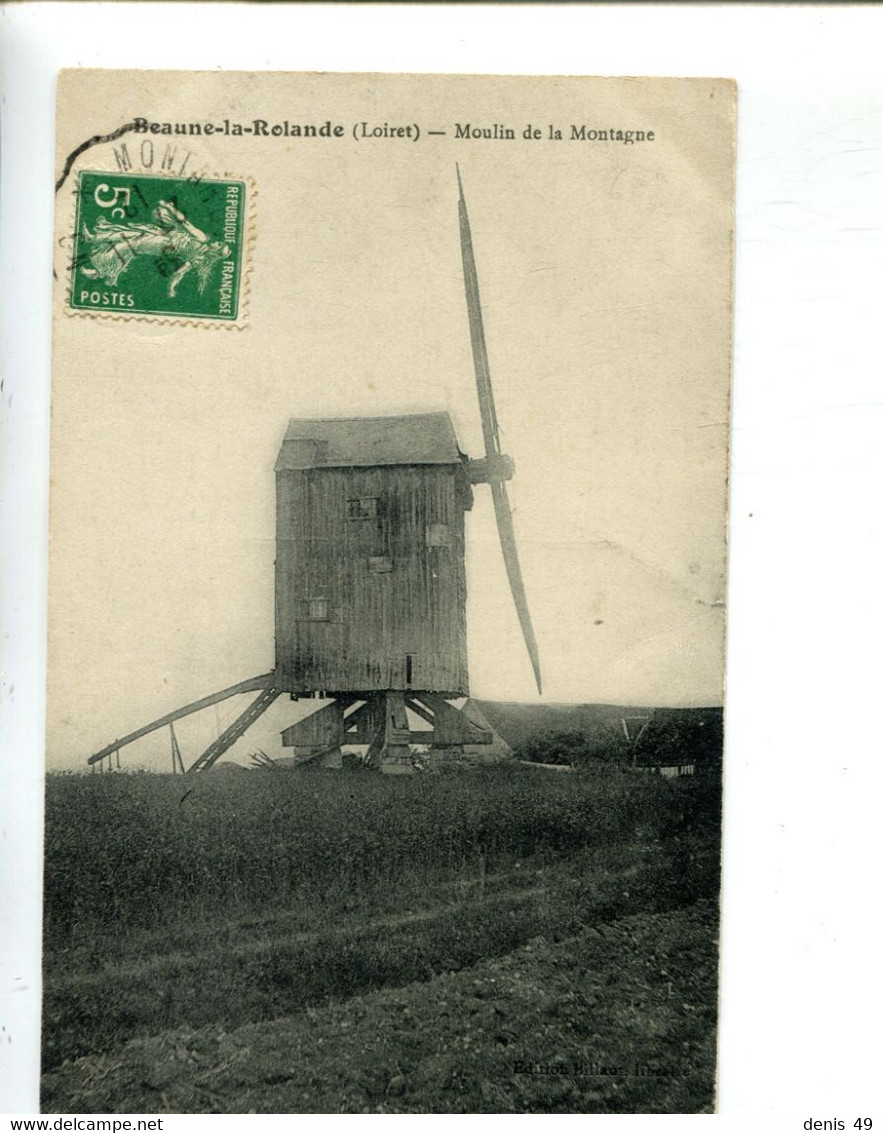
[282,690,493,775]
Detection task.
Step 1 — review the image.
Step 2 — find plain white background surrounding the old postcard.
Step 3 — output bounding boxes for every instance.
[0,3,883,1131]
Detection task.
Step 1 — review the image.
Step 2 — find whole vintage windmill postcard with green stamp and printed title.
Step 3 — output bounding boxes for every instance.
[42,70,736,1114]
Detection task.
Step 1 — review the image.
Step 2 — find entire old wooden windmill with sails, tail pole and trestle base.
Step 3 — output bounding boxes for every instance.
[88,172,542,774]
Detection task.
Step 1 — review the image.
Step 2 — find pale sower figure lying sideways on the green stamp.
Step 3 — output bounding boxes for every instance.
[82,201,230,298]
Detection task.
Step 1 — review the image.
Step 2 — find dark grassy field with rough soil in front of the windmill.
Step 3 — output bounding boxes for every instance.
[43,764,720,1113]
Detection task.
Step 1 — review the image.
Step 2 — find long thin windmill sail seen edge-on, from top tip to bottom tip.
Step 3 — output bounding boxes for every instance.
[457,167,543,692]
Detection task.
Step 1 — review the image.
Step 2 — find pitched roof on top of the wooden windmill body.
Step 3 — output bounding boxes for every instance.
[275,414,462,471]
